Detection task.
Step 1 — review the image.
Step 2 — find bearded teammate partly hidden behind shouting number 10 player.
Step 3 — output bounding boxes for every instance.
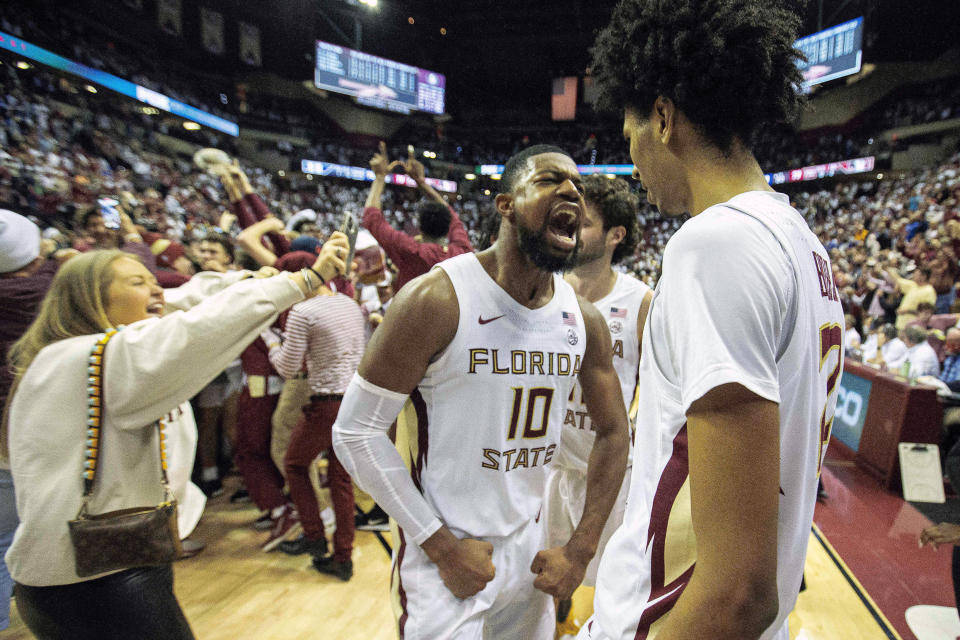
[544,175,653,622]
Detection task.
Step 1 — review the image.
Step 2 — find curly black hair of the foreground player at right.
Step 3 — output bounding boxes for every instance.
[592,0,804,153]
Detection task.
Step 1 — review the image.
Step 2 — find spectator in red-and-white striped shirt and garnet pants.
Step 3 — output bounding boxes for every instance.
[261,286,365,581]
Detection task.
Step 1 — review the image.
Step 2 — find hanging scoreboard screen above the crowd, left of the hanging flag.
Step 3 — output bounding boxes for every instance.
[314,40,447,115]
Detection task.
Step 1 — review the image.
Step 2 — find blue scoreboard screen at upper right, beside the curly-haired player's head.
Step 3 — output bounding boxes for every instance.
[793,16,863,88]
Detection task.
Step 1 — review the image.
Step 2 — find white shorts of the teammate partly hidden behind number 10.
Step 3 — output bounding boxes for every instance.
[543,466,630,587]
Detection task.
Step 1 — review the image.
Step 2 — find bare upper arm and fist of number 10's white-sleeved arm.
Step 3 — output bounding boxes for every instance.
[358,269,495,598]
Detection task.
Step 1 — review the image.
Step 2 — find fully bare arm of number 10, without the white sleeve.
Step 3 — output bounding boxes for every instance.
[530,298,630,600]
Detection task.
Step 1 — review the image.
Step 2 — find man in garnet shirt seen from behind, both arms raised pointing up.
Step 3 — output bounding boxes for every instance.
[363,142,473,291]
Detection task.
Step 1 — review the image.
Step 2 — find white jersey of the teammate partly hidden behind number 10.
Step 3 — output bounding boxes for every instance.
[554,272,650,473]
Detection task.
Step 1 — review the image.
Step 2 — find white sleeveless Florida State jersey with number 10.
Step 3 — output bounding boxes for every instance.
[410,253,586,537]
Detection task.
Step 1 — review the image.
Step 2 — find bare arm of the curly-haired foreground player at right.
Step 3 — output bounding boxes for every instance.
[657,384,780,640]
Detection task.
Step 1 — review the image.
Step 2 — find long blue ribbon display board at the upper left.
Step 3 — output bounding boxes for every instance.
[0,31,240,136]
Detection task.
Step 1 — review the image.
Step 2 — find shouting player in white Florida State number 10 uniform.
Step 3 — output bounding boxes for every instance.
[334,146,628,640]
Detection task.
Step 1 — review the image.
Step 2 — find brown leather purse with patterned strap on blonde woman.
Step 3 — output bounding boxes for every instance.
[67,329,183,578]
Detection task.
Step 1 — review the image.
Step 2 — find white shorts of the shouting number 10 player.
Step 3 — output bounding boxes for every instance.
[391,520,556,640]
